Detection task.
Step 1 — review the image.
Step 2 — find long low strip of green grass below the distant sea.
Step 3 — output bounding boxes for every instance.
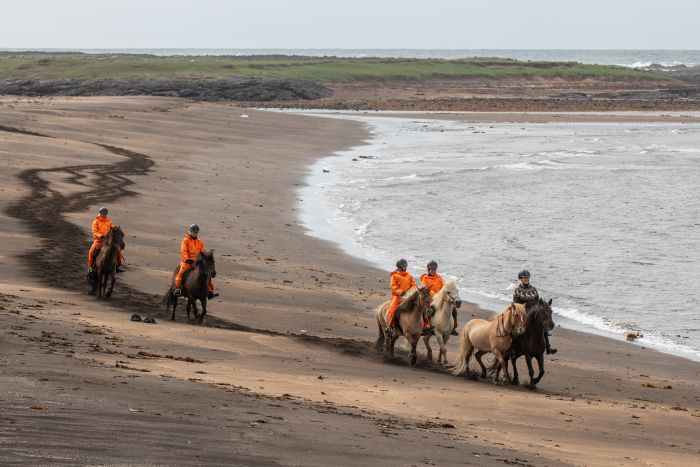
[0,53,666,82]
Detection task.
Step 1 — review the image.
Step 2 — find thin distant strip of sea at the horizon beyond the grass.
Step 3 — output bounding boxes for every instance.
[1,48,700,68]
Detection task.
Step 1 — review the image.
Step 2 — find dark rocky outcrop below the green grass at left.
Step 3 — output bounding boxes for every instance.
[0,78,332,101]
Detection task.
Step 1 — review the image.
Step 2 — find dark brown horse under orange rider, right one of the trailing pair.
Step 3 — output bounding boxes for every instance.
[163,250,216,324]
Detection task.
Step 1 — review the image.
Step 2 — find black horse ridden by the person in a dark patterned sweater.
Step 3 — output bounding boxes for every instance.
[506,298,554,389]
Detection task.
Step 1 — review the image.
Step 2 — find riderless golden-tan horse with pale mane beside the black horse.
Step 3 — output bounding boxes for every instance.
[450,303,526,384]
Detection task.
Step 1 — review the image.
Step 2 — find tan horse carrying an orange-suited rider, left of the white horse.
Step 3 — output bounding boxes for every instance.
[374,287,430,366]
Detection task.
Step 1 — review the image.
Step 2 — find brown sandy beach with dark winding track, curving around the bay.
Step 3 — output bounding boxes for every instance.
[0,97,700,466]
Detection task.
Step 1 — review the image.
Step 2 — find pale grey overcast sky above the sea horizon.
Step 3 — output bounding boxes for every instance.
[0,0,700,50]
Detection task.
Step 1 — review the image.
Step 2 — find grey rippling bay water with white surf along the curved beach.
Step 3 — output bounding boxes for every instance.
[300,112,700,361]
